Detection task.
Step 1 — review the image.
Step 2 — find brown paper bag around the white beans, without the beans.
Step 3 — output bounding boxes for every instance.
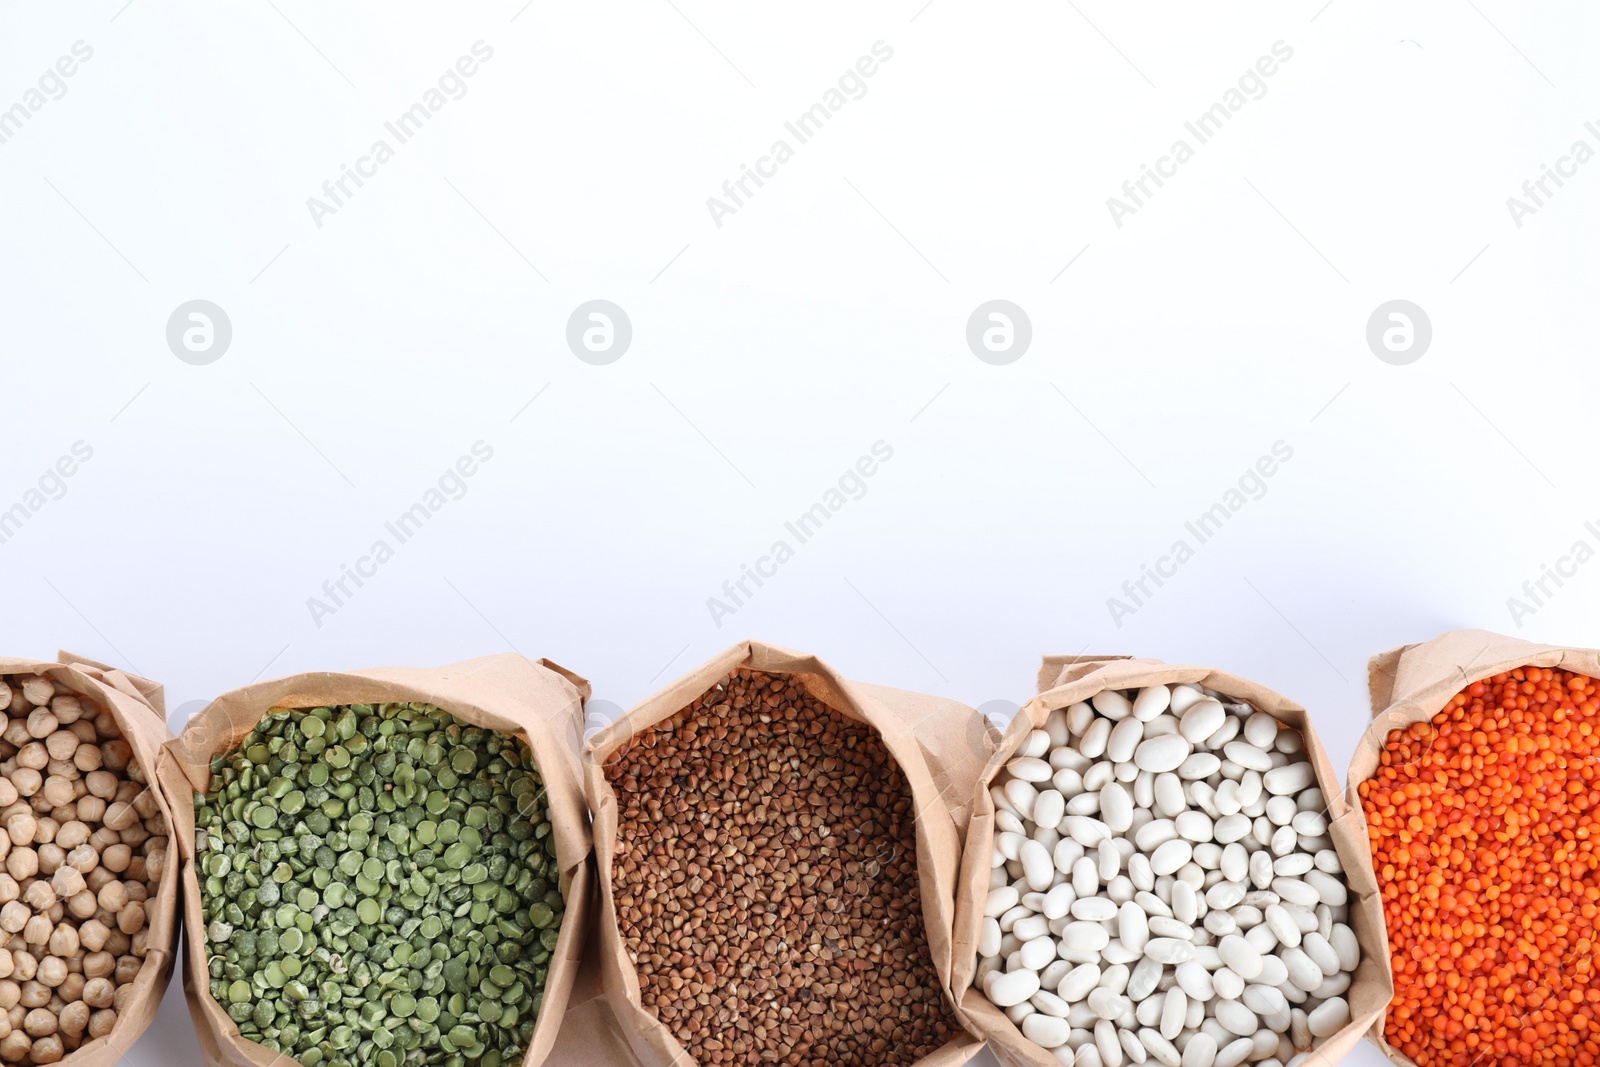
[954,656,1394,1067]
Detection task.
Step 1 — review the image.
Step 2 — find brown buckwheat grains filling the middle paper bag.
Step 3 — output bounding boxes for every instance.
[605,669,960,1067]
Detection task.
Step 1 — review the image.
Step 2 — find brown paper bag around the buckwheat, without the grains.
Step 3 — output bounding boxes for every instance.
[582,641,994,1067]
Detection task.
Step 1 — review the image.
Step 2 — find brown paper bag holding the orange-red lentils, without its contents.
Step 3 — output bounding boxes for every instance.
[1346,630,1600,1067]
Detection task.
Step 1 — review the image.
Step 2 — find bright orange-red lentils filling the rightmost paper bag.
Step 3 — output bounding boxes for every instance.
[1357,667,1600,1067]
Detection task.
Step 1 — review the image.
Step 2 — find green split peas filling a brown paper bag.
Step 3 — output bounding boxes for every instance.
[195,704,563,1067]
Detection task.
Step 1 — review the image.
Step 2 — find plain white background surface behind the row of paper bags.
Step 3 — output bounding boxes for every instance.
[0,0,1600,1067]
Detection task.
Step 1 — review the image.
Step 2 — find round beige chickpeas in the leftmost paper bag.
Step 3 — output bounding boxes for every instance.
[0,675,168,1064]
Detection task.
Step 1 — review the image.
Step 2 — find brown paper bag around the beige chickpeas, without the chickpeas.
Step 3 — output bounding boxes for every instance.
[0,653,179,1067]
